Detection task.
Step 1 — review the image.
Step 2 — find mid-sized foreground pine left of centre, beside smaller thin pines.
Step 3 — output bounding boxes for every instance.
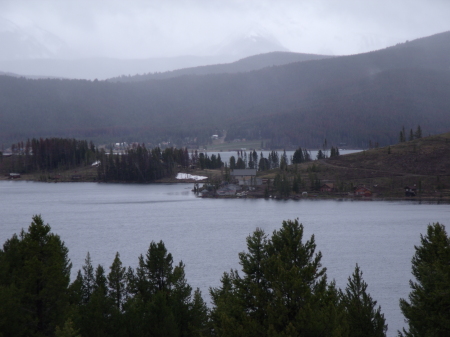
[124,241,207,336]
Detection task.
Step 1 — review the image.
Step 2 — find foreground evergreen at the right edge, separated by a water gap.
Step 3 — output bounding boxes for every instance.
[399,223,450,337]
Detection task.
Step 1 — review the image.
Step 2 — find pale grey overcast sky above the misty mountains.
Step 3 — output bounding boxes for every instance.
[0,0,450,58]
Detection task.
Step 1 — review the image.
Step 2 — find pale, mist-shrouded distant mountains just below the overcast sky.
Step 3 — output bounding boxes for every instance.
[0,18,287,80]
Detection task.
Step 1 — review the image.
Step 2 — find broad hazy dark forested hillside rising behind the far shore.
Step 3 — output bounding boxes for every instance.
[0,32,450,147]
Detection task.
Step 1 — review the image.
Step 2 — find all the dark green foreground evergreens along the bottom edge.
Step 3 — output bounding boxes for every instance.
[0,216,450,337]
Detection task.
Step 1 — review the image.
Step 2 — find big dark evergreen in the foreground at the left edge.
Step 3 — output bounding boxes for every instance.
[0,215,71,336]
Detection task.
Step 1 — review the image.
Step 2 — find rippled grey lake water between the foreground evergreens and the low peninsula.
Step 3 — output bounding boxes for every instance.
[0,181,450,336]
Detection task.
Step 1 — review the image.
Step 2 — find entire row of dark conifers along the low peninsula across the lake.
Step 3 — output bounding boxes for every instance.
[0,138,312,183]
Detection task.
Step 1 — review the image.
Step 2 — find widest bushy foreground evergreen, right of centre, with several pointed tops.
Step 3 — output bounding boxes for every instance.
[210,220,347,336]
